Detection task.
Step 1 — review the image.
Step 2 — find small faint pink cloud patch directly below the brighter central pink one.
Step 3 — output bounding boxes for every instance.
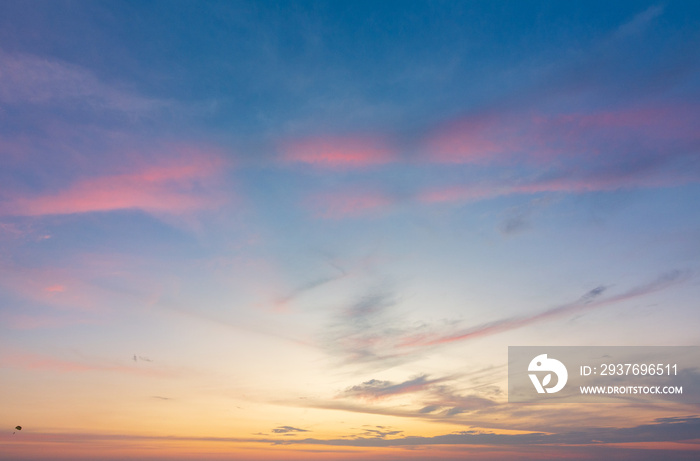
[306,191,394,219]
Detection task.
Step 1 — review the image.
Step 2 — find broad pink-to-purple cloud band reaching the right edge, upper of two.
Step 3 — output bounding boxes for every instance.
[423,104,700,164]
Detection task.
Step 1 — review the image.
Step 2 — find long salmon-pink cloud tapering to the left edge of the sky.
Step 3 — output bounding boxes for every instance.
[0,146,225,216]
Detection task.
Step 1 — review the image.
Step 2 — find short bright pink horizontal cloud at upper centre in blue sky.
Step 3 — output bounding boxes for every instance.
[281,137,396,169]
